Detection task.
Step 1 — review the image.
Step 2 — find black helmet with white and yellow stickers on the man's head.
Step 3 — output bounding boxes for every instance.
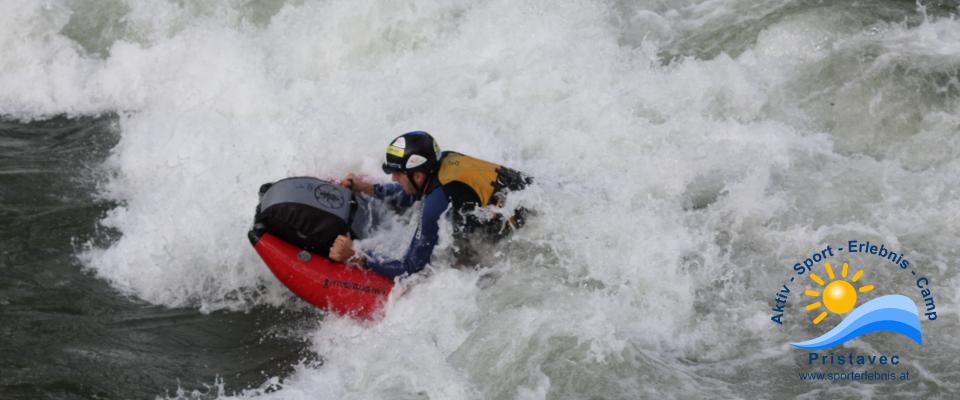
[383,131,440,174]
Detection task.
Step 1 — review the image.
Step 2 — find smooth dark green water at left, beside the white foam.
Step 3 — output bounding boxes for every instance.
[0,116,318,399]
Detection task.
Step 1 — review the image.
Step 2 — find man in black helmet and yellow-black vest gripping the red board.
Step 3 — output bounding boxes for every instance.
[330,131,533,278]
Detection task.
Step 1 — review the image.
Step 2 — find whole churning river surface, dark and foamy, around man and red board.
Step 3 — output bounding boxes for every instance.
[0,0,960,399]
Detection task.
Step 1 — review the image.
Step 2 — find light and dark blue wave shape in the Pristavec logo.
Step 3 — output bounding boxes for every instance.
[791,294,923,350]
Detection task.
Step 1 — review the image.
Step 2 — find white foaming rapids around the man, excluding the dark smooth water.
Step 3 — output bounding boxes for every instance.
[0,1,960,399]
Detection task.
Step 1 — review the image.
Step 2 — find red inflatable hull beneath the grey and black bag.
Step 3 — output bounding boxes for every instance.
[249,229,393,319]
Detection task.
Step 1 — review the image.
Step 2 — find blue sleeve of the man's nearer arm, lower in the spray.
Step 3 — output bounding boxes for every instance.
[367,189,450,278]
